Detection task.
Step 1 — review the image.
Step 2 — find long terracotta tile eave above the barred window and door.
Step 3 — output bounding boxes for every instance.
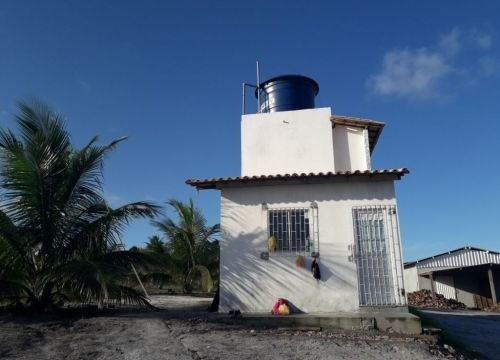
[186,168,410,189]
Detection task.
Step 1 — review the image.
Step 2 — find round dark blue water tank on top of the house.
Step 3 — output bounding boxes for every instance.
[255,75,319,112]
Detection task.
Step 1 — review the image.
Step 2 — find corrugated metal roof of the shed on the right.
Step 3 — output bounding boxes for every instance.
[405,247,500,269]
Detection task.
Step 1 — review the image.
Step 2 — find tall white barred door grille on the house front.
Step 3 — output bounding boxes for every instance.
[353,205,406,306]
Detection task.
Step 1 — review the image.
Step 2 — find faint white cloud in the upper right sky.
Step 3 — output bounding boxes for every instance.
[367,28,499,98]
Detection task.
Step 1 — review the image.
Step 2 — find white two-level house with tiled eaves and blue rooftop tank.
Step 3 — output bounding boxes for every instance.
[187,75,408,313]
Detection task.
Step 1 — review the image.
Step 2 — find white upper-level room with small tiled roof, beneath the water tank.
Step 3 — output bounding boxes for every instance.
[241,108,385,176]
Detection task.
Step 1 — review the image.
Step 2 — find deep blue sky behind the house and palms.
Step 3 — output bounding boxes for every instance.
[0,0,500,260]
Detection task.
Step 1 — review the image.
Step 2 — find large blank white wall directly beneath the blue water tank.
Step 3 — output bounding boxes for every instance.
[241,108,335,176]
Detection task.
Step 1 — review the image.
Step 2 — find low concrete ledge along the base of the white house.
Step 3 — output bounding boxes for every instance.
[217,313,422,335]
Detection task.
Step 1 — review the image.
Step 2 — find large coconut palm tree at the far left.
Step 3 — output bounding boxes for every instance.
[0,102,159,311]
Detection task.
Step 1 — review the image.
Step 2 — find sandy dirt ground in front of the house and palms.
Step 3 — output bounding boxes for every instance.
[0,296,460,360]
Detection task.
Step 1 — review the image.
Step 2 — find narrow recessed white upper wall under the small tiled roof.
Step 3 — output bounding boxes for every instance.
[333,125,370,171]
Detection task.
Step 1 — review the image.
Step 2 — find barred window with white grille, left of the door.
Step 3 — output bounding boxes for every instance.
[267,208,318,254]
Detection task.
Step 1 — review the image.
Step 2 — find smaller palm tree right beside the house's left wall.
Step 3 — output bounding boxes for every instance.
[153,199,220,291]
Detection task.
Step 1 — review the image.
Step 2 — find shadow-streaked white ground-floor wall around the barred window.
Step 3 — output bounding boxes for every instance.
[219,181,395,313]
